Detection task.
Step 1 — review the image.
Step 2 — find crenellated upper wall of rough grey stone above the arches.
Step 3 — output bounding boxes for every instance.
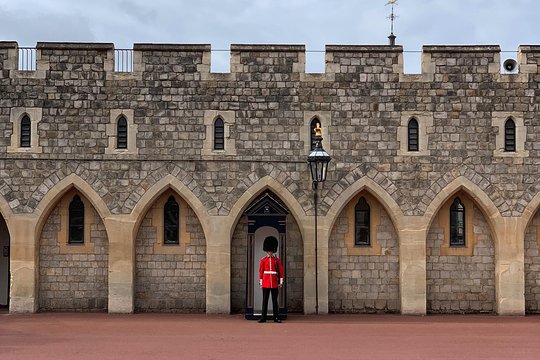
[0,42,540,216]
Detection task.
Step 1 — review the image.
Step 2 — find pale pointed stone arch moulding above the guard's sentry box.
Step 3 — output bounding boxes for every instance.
[229,175,307,239]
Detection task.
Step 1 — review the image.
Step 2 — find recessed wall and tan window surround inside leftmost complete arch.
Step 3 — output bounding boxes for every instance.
[38,187,109,311]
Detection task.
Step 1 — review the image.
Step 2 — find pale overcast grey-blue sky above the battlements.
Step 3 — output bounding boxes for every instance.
[0,0,540,71]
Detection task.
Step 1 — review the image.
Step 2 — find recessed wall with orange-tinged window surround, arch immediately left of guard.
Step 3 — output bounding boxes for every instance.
[134,188,207,313]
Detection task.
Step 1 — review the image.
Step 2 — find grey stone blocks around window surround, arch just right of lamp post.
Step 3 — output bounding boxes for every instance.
[328,210,400,313]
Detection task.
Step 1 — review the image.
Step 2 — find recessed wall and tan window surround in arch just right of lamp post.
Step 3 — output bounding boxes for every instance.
[328,190,400,313]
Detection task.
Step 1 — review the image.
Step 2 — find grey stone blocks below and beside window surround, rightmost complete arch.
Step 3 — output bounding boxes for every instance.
[427,207,495,313]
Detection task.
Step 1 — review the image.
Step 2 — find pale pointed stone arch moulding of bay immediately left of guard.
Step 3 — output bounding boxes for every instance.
[130,174,210,238]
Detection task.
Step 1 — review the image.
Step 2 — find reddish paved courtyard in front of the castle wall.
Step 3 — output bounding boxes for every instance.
[0,313,540,360]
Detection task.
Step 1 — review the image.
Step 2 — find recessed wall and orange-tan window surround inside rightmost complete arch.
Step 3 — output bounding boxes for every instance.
[426,190,496,313]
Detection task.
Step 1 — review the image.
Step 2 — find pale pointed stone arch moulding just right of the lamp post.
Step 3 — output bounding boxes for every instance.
[325,176,405,238]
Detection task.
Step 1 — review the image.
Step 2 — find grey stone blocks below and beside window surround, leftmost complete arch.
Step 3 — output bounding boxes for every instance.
[38,207,109,311]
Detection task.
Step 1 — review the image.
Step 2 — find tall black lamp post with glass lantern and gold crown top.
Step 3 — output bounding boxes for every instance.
[308,124,331,314]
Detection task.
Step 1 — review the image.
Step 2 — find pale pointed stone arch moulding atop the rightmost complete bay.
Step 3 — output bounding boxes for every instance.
[423,176,502,244]
